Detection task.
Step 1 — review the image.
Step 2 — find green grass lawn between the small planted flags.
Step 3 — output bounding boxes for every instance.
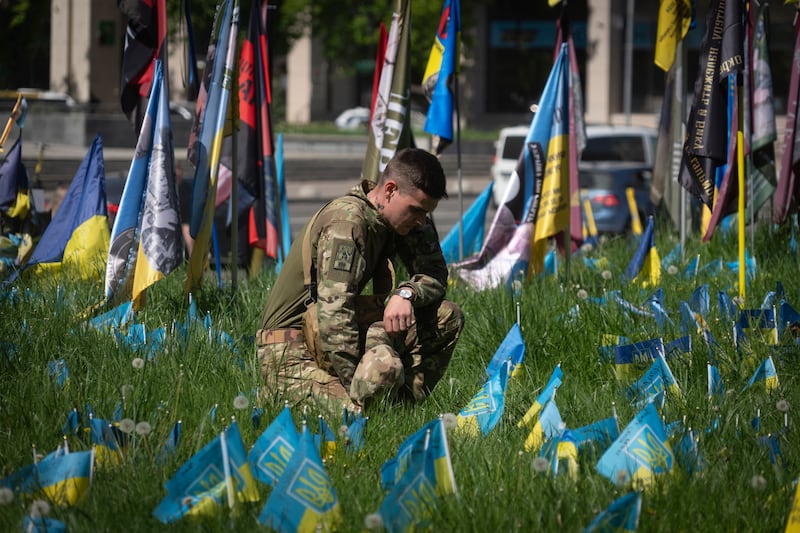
[0,222,800,531]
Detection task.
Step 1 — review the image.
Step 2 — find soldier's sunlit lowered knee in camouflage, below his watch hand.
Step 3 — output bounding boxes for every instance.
[350,345,405,405]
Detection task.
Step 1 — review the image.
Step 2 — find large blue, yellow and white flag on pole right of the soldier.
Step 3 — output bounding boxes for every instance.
[455,44,569,289]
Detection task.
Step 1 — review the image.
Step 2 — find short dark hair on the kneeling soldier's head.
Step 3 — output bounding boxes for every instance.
[380,148,447,200]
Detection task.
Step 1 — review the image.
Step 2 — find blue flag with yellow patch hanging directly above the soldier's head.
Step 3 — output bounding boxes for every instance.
[422,0,461,154]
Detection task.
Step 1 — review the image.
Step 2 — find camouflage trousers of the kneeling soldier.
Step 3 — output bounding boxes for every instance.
[258,300,464,412]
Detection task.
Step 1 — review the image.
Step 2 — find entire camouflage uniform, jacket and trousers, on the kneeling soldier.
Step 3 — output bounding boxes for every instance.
[256,182,464,407]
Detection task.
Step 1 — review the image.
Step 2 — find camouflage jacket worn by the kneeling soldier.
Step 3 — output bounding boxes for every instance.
[262,182,447,386]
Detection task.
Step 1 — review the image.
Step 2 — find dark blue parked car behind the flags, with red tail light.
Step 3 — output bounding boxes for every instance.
[578,162,655,233]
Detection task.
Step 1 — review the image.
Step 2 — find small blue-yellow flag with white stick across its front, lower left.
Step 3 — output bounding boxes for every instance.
[153,421,258,524]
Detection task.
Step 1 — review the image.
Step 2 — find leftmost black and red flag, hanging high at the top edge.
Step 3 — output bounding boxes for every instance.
[117,0,167,134]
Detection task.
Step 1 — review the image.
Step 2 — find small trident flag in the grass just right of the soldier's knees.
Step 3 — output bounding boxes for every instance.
[457,359,511,437]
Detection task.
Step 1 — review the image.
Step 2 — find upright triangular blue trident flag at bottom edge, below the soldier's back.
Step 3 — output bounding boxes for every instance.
[258,424,342,533]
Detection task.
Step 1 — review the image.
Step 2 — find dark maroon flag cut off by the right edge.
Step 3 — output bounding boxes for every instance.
[772,11,800,224]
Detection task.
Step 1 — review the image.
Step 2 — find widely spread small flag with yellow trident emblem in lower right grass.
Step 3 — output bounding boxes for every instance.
[596,402,675,487]
